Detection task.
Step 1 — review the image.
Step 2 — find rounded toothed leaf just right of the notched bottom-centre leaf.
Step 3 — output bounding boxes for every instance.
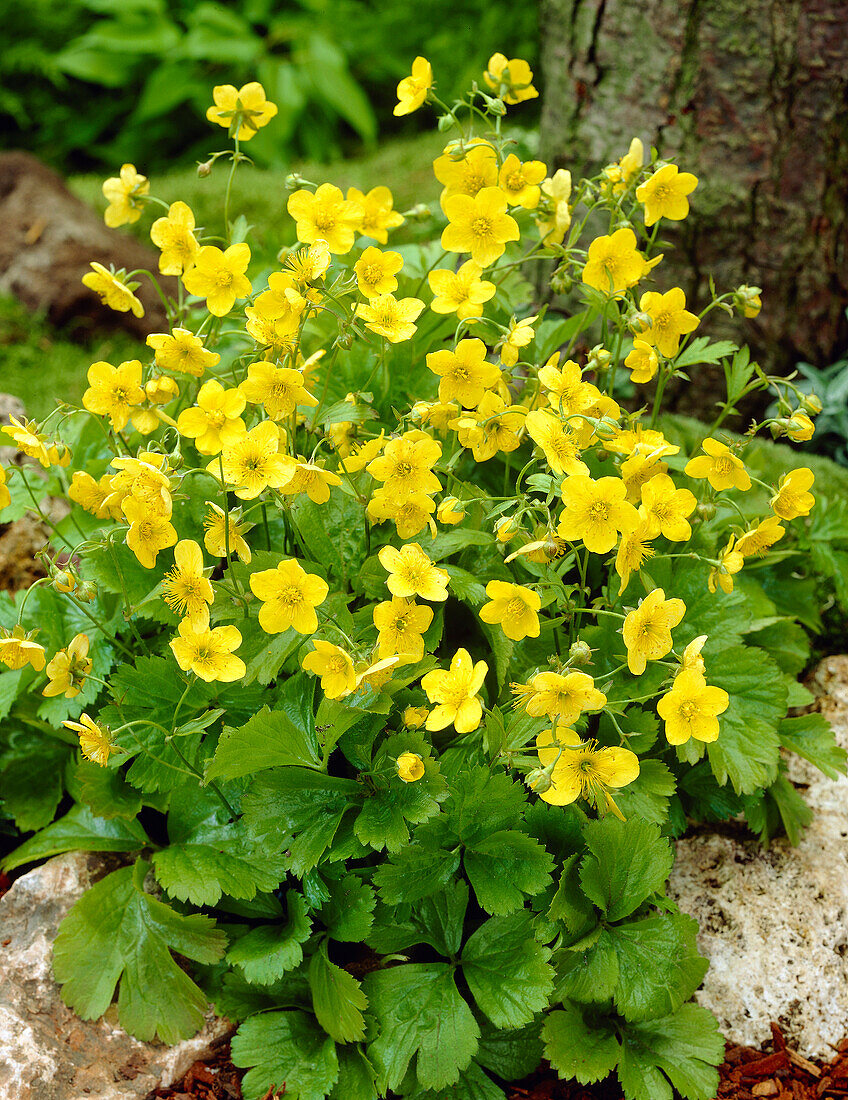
[462,910,553,1027]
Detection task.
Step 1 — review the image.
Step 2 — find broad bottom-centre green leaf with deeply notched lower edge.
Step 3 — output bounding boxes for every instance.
[365,963,480,1090]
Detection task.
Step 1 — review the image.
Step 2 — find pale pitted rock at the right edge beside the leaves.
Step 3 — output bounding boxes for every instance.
[669,657,848,1059]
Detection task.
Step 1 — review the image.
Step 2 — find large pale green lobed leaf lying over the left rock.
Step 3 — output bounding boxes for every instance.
[53,860,225,1043]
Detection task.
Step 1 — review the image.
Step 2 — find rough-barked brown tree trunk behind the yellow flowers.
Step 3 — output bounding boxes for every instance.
[541,0,848,382]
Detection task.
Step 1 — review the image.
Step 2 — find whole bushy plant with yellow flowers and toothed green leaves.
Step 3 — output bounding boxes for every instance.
[0,54,845,1100]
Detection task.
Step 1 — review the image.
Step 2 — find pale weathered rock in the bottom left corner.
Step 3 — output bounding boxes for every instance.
[0,853,230,1100]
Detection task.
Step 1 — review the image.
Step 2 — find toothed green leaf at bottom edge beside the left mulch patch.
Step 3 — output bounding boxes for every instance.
[231,1011,339,1100]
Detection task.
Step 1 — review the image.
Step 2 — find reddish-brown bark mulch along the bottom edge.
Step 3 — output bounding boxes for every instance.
[146,1024,848,1100]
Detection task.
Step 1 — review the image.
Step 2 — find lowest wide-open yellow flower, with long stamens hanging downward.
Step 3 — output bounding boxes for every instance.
[536,728,639,817]
